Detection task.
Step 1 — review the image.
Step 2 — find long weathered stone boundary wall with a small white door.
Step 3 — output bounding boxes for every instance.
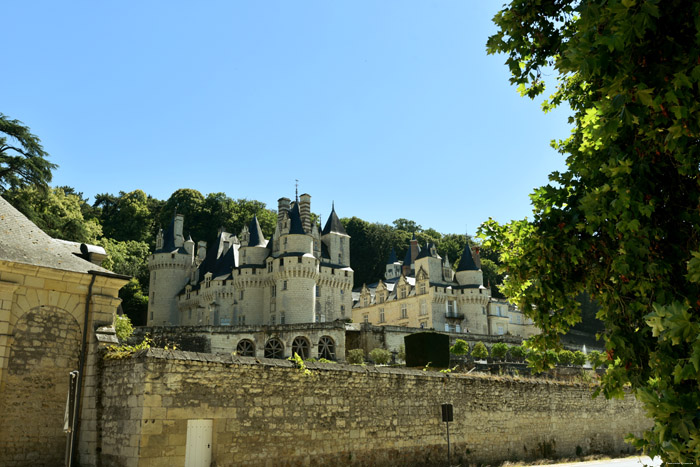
[98,349,650,466]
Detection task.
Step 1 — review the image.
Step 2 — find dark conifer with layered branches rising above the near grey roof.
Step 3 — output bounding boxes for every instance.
[0,113,58,194]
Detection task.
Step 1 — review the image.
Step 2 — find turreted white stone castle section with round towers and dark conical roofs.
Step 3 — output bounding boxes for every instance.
[147,194,353,326]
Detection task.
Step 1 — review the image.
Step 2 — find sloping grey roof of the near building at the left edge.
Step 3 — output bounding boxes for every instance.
[0,197,110,273]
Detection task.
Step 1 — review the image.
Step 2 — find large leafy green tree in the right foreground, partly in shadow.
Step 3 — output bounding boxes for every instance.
[481,0,700,463]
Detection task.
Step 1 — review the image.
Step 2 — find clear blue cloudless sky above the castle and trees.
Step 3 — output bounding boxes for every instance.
[0,0,569,233]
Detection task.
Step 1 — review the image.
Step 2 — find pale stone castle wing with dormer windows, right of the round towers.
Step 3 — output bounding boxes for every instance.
[352,235,538,337]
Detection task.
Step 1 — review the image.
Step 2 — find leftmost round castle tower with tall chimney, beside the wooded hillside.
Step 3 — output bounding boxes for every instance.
[146,214,194,326]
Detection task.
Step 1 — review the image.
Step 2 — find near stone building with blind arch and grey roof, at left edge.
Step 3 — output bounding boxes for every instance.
[0,198,128,466]
